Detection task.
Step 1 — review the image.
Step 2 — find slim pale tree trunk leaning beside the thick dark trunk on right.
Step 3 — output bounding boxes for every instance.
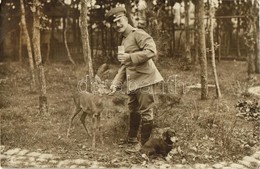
[209,0,221,98]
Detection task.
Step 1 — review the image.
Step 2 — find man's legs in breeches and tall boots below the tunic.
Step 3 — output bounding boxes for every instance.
[128,86,155,144]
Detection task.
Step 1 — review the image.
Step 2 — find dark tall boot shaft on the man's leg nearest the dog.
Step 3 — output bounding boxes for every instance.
[141,120,153,145]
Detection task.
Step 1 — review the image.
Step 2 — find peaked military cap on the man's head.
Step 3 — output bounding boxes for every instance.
[105,7,126,23]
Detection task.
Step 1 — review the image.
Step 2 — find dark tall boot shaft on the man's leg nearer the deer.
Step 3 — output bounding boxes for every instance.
[128,113,141,143]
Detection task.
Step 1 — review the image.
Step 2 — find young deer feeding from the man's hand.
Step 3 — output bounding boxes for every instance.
[67,73,122,148]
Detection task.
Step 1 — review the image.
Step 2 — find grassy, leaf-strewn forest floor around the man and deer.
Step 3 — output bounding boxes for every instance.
[0,59,260,167]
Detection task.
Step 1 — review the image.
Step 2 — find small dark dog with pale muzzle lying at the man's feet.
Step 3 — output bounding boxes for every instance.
[140,128,177,158]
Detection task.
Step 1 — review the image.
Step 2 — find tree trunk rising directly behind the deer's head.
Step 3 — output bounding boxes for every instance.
[80,0,94,80]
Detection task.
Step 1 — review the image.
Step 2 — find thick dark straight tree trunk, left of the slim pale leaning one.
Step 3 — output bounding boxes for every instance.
[196,0,208,100]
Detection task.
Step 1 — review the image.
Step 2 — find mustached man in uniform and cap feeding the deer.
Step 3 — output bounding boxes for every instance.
[106,7,163,151]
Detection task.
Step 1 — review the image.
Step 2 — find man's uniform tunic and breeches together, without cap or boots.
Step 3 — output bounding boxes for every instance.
[112,28,163,122]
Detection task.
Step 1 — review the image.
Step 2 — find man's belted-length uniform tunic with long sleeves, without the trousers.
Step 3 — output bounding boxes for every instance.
[112,29,163,92]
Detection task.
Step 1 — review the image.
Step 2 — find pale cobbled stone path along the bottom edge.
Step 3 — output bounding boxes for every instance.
[0,145,260,169]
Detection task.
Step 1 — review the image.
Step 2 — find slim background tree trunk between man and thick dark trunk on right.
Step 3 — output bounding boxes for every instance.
[185,0,191,65]
